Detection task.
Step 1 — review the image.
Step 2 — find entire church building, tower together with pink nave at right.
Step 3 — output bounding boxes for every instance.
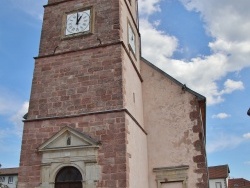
[18,0,208,188]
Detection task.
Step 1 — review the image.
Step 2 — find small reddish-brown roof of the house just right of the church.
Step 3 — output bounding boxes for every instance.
[208,165,230,179]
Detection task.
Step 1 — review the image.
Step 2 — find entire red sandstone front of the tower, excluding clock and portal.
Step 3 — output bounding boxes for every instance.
[18,0,145,188]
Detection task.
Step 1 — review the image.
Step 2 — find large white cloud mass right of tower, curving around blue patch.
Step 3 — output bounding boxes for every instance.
[139,0,250,105]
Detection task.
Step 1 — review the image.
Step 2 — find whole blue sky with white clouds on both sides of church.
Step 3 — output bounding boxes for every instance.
[0,0,250,180]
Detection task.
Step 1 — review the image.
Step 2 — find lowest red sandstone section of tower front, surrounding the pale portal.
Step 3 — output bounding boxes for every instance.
[18,112,128,188]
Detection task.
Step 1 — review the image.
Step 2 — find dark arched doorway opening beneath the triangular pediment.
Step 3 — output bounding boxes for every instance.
[55,166,82,188]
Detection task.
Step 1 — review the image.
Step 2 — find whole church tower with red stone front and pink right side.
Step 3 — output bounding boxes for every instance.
[18,0,148,188]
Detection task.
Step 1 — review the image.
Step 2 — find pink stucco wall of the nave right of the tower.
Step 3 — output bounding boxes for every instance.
[141,62,206,188]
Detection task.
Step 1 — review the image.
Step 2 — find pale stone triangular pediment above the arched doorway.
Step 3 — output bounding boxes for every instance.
[38,126,100,151]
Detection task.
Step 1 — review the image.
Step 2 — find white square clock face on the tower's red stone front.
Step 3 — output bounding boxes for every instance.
[65,10,91,35]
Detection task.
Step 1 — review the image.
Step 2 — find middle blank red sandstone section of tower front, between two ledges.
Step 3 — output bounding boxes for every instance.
[28,45,123,119]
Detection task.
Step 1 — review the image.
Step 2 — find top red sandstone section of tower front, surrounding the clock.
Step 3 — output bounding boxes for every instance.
[39,0,120,56]
